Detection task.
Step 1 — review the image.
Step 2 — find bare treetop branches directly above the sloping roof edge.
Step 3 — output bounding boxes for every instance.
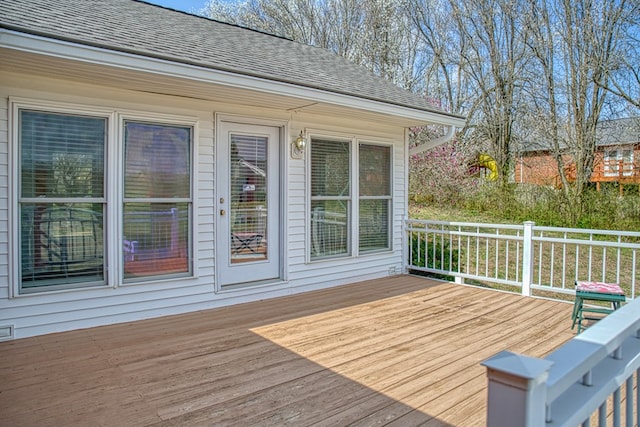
[204,0,423,90]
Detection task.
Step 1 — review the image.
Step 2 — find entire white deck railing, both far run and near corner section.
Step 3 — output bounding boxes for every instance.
[405,220,640,427]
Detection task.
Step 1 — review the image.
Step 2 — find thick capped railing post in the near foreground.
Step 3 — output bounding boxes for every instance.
[482,351,553,427]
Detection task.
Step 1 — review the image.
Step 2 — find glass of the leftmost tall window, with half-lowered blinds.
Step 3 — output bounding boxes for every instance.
[18,110,107,292]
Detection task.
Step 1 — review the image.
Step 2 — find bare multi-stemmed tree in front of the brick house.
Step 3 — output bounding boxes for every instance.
[525,0,633,224]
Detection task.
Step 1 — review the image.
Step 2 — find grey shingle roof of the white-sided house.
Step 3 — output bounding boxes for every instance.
[0,0,460,119]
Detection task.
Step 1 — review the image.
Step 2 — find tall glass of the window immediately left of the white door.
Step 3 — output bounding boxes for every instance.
[123,121,191,279]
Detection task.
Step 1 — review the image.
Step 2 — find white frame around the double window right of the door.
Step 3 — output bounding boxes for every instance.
[305,130,395,263]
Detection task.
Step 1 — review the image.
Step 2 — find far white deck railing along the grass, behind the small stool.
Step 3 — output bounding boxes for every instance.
[405,220,640,299]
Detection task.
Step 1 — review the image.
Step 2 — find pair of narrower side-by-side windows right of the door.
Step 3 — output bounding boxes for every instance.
[310,137,392,260]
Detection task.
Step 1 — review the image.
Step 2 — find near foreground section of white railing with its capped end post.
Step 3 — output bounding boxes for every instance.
[483,299,640,427]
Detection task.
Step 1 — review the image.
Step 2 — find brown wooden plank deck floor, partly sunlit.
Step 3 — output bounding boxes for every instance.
[0,276,573,426]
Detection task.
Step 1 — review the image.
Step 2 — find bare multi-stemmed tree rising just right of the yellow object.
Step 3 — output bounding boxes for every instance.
[407,0,530,186]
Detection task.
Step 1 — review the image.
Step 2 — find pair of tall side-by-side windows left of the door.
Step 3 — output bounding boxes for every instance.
[14,105,193,294]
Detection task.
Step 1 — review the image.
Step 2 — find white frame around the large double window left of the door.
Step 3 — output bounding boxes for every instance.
[8,97,198,298]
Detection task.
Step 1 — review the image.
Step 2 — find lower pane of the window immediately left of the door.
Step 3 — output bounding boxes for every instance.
[123,203,190,278]
